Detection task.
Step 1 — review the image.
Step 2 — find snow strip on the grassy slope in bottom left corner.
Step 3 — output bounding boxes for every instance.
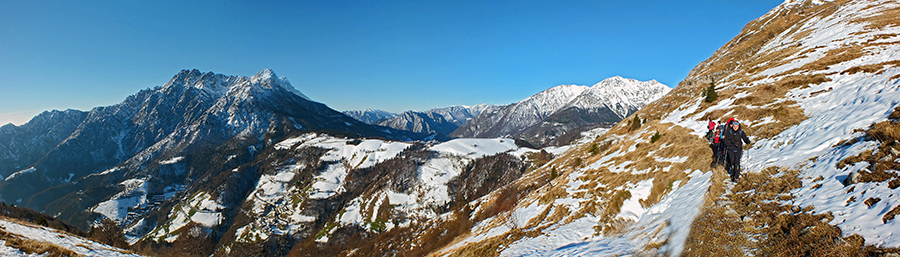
[0,218,140,257]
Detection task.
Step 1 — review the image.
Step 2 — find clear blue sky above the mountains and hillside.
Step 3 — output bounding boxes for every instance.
[0,0,782,124]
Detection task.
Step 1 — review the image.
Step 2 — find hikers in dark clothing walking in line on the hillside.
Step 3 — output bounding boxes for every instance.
[706,118,750,183]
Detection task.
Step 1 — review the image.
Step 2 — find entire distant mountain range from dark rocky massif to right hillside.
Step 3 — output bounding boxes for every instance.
[344,76,671,147]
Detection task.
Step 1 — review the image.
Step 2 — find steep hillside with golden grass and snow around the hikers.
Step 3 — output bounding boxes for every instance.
[435,1,900,256]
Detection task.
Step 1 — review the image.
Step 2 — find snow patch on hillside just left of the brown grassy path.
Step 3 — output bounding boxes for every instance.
[503,171,712,256]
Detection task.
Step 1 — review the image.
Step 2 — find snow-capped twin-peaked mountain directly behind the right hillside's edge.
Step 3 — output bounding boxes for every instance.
[450,76,671,146]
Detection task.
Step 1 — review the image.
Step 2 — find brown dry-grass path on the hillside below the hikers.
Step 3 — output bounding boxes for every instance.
[683,168,898,256]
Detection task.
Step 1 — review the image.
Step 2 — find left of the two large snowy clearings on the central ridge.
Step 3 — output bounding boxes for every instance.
[235,133,411,242]
